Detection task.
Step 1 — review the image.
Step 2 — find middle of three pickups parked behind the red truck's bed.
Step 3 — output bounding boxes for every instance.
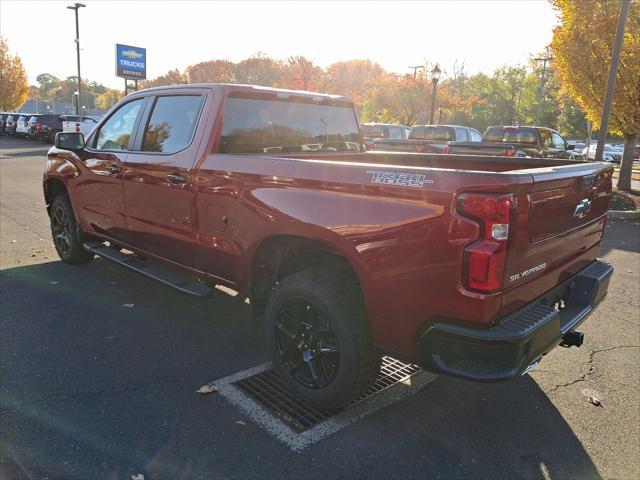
[373,125,482,153]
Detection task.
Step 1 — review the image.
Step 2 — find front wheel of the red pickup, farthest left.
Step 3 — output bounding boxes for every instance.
[50,194,94,265]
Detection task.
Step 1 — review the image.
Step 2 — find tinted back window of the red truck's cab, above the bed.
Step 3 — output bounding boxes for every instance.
[220,97,360,153]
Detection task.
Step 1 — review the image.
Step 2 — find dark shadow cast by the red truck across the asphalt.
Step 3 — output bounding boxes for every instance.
[0,259,600,479]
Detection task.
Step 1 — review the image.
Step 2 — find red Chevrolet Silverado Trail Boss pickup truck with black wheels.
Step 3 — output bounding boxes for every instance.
[44,84,613,408]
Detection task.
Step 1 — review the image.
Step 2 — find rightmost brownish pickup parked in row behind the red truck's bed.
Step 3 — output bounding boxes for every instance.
[449,125,580,160]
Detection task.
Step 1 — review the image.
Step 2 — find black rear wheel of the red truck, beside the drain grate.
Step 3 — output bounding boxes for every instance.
[265,269,380,410]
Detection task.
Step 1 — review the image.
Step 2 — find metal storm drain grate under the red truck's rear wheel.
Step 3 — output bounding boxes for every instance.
[234,357,422,432]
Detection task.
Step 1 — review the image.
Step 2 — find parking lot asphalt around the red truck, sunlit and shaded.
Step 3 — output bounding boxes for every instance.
[0,137,640,479]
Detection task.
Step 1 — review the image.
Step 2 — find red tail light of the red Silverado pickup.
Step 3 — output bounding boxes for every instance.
[457,193,513,293]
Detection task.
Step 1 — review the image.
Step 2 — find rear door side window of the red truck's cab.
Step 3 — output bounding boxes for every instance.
[142,95,202,154]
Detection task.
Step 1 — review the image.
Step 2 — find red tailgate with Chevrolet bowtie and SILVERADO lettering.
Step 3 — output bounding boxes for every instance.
[502,162,613,315]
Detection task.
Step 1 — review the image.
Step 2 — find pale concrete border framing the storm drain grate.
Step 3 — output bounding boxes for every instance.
[211,362,437,452]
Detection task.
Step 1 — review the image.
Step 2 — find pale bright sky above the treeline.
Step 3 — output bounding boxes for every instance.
[0,0,557,89]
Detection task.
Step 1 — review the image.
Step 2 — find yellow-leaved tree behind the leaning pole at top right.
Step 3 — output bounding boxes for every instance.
[551,0,640,190]
